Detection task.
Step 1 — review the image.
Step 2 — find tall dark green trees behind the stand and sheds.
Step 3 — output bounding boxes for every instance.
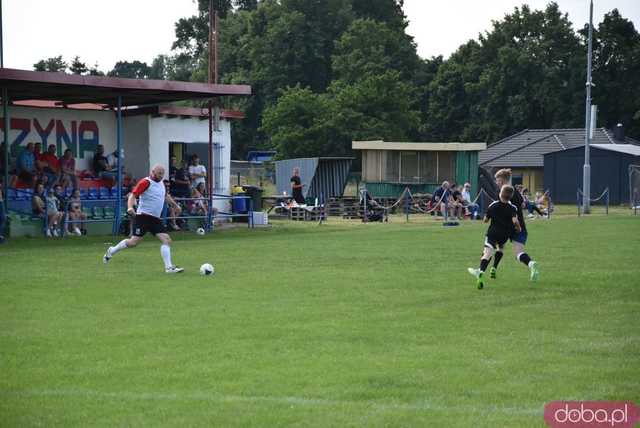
[35,0,640,158]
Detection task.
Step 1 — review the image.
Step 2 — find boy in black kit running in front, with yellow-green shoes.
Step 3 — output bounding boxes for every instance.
[468,185,522,290]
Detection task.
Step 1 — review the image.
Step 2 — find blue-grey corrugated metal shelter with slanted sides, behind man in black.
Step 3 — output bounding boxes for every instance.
[275,157,354,200]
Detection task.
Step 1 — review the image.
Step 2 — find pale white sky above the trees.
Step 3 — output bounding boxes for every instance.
[0,0,640,71]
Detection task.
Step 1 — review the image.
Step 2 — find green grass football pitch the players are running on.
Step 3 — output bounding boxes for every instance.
[0,210,640,427]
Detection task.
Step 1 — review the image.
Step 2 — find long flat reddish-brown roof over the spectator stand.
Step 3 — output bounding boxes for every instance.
[0,68,251,106]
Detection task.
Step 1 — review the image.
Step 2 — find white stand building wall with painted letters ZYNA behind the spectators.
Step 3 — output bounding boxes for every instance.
[0,101,244,209]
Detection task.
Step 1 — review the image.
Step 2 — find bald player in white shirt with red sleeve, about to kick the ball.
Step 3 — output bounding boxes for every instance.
[102,165,184,273]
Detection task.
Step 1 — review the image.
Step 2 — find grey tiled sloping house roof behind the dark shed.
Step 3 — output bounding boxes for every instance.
[478,128,640,168]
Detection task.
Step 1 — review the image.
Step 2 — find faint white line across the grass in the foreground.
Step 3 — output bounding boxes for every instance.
[0,389,543,416]
